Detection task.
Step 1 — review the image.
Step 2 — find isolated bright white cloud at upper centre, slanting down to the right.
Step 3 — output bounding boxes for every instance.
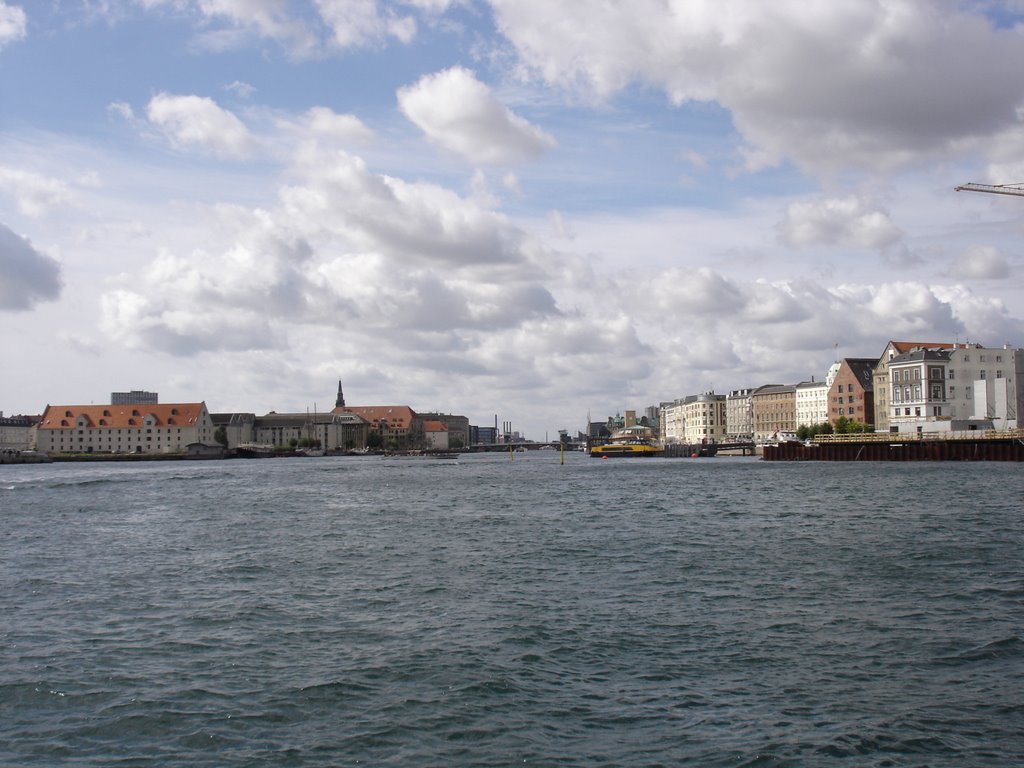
[398,67,555,165]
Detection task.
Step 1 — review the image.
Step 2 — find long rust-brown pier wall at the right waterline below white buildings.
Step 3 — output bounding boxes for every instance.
[764,429,1024,462]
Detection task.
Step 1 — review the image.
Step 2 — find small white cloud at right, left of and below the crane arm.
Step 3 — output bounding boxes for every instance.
[777,196,902,249]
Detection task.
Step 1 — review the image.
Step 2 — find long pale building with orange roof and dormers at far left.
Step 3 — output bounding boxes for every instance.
[36,402,218,454]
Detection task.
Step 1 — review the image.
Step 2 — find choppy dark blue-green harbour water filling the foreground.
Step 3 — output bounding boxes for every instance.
[0,452,1024,768]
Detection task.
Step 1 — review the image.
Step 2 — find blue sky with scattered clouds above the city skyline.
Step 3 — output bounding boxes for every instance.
[0,0,1024,439]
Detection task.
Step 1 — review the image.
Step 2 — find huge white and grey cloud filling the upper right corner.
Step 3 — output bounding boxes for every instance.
[492,0,1024,175]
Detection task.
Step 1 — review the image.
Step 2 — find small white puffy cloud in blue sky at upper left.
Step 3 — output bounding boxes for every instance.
[145,93,256,158]
